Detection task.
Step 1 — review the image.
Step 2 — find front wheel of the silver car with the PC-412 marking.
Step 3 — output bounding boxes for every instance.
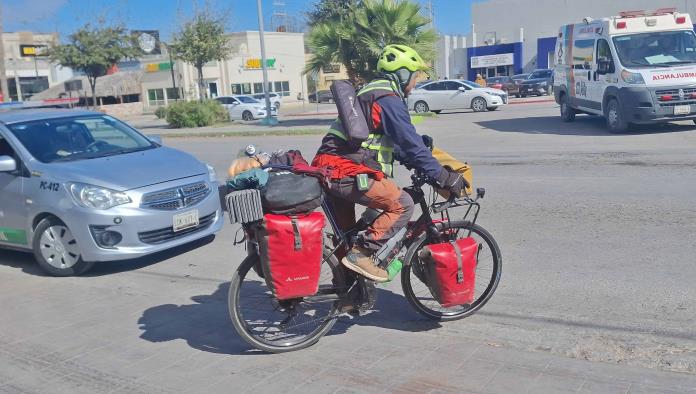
[32,217,94,276]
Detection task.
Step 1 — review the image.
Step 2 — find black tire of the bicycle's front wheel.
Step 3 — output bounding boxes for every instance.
[401,221,503,321]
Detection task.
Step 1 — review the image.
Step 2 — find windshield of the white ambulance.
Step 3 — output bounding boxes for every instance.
[613,30,696,67]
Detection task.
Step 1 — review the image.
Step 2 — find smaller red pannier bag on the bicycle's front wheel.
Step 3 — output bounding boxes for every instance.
[419,237,478,308]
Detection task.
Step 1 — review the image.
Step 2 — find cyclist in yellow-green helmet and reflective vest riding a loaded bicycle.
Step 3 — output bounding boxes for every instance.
[312,45,467,282]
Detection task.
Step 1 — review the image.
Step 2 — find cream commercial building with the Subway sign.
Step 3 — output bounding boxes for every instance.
[141,31,307,110]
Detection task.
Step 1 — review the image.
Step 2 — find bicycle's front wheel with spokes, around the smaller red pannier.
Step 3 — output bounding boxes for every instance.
[401,221,503,321]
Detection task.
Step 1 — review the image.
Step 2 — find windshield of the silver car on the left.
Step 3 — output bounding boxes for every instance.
[8,115,157,163]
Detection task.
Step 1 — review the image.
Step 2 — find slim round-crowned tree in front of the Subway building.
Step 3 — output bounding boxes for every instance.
[169,11,232,101]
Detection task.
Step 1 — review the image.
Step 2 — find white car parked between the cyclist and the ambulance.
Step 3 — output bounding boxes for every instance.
[408,79,508,113]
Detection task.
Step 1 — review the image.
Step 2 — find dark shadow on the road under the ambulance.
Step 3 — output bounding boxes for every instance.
[474,115,694,137]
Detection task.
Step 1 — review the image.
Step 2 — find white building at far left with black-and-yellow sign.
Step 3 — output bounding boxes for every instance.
[2,32,72,101]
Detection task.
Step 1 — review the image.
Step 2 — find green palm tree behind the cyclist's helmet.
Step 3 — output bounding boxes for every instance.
[305,0,437,84]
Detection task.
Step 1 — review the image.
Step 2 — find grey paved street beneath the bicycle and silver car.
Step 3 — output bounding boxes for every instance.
[0,103,696,392]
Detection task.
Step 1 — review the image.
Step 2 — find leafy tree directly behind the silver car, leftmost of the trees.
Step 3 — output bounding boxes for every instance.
[48,23,140,108]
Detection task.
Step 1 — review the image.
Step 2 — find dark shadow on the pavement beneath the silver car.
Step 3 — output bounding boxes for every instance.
[0,235,215,277]
